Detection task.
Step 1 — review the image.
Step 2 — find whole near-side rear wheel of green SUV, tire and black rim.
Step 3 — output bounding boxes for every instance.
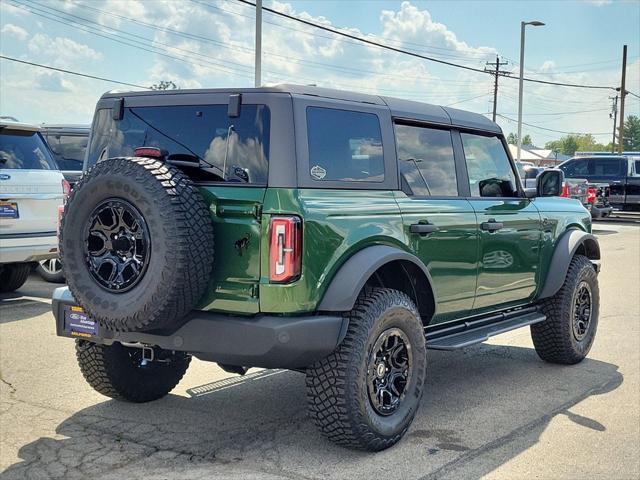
[306,288,427,451]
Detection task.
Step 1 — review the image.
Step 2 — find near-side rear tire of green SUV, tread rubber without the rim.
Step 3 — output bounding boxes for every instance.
[306,288,426,451]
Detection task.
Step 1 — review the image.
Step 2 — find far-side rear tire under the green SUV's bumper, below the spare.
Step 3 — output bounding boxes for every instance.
[76,340,191,403]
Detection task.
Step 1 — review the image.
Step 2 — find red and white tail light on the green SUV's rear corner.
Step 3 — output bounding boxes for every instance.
[269,216,302,283]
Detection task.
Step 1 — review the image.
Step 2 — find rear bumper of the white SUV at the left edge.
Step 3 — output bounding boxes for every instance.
[0,232,58,263]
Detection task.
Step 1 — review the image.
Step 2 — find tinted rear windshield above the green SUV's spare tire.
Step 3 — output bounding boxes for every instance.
[88,104,270,185]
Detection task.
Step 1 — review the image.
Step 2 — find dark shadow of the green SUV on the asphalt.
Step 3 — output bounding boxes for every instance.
[0,345,623,479]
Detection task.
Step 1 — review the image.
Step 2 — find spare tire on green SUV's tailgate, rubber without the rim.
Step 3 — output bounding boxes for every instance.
[60,157,214,331]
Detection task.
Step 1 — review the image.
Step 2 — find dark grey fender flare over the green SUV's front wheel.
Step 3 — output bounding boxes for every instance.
[538,229,600,298]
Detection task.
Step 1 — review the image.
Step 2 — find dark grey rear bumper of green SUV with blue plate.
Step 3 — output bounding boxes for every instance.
[52,287,348,368]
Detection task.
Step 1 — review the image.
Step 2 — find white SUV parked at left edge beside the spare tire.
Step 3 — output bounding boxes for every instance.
[0,120,68,292]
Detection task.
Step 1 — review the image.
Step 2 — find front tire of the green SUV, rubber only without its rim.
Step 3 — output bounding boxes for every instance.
[531,255,600,365]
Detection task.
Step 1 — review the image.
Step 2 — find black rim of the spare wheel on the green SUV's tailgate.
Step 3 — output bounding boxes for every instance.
[84,198,151,293]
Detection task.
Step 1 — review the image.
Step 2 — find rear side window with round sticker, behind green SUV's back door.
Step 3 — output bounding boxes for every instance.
[307,107,384,182]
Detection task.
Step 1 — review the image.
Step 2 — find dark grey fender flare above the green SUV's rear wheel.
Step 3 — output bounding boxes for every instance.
[318,245,433,312]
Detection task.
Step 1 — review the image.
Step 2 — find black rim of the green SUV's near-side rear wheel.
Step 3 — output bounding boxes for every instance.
[367,328,413,416]
